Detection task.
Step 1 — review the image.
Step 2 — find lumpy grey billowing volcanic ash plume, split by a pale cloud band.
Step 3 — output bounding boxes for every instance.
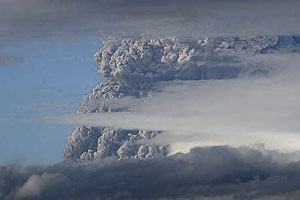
[64,35,300,160]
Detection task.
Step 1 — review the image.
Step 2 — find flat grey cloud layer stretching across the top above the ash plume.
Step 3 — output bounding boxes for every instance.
[0,0,300,43]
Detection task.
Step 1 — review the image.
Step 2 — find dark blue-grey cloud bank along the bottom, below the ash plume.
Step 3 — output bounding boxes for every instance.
[0,146,300,200]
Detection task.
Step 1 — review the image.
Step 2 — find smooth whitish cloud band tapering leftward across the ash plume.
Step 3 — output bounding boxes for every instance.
[42,55,300,152]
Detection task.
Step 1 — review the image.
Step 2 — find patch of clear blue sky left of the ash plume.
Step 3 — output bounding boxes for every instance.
[0,37,101,164]
